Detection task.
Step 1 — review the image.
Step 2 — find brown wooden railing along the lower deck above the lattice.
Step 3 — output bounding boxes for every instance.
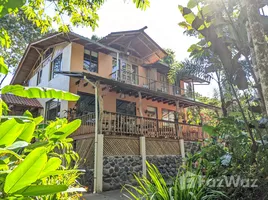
[74,112,206,141]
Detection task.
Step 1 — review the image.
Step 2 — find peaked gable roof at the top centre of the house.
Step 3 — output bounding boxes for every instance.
[99,26,167,64]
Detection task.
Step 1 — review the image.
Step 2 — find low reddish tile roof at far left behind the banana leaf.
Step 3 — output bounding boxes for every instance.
[1,94,43,108]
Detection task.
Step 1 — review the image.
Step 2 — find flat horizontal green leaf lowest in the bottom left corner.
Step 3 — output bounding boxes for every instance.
[16,185,68,196]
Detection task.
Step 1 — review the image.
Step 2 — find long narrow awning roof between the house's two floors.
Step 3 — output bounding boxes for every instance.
[57,71,220,110]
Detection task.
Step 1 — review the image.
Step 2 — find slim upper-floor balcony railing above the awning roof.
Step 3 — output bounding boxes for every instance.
[111,70,195,99]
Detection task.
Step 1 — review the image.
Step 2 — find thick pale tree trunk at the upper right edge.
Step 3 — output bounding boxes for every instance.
[244,0,268,114]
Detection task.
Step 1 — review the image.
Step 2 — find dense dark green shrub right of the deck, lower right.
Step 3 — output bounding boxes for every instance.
[192,117,268,199]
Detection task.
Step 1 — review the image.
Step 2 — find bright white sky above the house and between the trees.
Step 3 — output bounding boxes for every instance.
[2,0,216,97]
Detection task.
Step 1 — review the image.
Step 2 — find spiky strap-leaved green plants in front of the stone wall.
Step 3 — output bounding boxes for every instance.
[123,162,227,200]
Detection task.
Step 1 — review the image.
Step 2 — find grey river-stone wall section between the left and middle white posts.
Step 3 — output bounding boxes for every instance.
[103,156,142,191]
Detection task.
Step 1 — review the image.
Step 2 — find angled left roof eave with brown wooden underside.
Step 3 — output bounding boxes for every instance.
[11,32,119,85]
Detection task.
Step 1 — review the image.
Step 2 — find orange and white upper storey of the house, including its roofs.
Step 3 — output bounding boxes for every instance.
[11,29,210,102]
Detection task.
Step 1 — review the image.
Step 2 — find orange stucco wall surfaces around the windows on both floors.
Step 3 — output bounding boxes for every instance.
[68,43,186,119]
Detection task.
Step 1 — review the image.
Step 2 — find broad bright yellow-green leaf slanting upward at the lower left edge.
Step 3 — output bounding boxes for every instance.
[4,147,47,194]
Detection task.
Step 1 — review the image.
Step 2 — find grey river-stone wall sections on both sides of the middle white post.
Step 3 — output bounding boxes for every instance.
[103,155,182,191]
